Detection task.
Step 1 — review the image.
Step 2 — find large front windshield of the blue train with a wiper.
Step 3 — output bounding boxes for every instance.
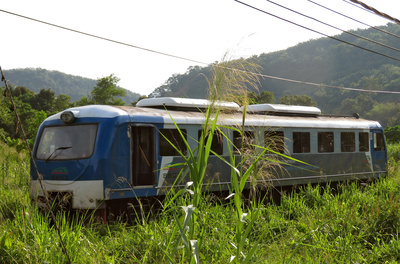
[36,124,97,162]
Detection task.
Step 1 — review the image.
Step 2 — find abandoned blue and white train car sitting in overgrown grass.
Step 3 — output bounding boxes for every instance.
[30,97,387,219]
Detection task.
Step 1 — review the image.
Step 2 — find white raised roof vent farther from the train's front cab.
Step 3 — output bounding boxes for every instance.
[242,104,321,116]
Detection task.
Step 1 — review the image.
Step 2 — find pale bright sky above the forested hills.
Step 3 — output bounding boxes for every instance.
[0,0,400,95]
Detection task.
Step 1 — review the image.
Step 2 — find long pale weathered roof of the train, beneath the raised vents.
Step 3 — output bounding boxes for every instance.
[46,100,381,129]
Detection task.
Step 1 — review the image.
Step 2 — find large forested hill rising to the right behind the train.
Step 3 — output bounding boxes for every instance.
[150,23,400,125]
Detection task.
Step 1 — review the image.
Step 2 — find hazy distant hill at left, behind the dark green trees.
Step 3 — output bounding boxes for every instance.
[4,68,140,104]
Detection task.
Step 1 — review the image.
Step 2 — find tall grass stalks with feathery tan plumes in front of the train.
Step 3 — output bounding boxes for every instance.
[159,55,312,263]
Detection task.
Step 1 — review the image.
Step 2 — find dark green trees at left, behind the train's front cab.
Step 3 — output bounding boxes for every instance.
[0,74,131,150]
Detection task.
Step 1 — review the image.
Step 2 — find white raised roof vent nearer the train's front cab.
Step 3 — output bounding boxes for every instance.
[136,97,240,111]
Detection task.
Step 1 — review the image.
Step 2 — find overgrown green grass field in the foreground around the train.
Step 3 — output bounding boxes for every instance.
[0,144,400,263]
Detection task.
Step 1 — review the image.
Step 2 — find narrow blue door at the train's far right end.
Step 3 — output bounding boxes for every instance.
[371,130,387,172]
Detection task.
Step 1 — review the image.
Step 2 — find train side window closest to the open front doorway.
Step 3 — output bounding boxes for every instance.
[159,129,187,156]
